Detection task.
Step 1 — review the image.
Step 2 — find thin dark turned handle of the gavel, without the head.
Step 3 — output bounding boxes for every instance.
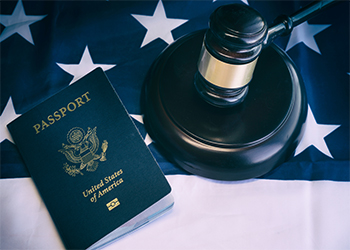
[263,0,338,47]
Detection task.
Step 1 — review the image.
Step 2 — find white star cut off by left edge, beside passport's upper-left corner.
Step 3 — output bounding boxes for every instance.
[0,97,20,144]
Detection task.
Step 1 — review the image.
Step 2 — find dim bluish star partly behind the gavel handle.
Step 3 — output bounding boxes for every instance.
[286,22,331,54]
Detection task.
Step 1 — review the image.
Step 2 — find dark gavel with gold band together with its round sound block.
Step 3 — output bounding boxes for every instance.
[144,0,334,180]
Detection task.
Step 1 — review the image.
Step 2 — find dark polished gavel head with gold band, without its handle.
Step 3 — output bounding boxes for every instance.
[195,4,268,107]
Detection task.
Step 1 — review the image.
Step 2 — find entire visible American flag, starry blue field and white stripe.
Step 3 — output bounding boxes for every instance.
[0,0,350,249]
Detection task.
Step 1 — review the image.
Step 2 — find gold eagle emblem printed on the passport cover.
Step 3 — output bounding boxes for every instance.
[58,127,108,177]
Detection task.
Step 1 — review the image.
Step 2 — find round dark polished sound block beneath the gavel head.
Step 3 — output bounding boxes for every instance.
[144,30,307,180]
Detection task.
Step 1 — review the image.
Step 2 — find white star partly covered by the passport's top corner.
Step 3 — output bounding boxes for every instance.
[56,46,116,85]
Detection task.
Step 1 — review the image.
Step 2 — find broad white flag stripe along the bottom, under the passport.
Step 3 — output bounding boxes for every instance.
[0,175,350,250]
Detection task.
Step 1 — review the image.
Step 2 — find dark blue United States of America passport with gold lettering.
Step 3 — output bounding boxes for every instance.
[8,68,173,249]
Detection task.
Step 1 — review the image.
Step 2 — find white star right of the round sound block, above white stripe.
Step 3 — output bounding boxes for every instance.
[294,106,340,158]
